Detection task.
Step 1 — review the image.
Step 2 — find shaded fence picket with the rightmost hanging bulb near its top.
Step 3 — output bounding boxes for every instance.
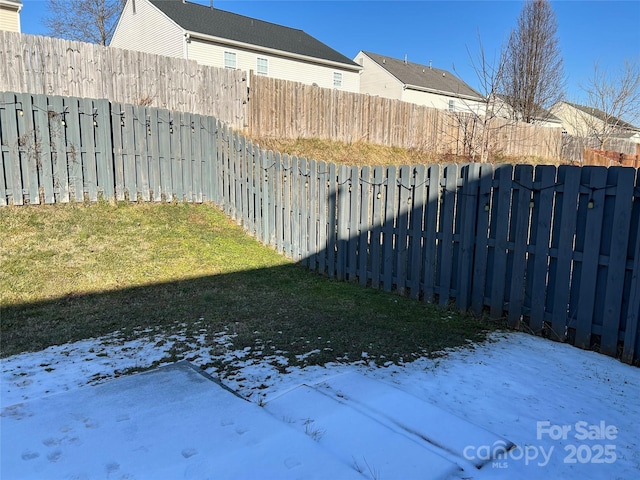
[575,167,607,348]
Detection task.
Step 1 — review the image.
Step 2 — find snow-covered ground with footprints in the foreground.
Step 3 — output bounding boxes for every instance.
[0,333,640,480]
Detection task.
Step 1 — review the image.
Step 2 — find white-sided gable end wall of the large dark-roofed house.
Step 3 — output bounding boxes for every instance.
[109,0,185,58]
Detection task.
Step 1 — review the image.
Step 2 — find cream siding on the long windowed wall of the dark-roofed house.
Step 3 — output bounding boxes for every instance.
[188,36,360,93]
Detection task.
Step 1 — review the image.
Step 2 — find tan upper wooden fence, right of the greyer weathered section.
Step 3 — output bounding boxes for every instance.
[248,75,562,160]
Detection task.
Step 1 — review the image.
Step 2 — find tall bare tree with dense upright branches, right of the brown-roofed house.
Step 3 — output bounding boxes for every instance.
[500,0,564,123]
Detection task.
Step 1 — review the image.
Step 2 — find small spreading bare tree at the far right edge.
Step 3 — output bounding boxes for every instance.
[581,58,640,149]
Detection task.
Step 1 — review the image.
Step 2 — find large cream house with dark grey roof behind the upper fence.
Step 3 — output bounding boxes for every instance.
[110,0,360,92]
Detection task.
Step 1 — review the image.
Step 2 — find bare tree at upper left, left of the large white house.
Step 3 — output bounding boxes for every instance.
[44,0,126,45]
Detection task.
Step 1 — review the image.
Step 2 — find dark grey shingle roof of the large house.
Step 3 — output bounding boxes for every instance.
[149,0,359,67]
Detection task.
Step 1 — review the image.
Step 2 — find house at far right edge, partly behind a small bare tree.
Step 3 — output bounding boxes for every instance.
[551,102,640,143]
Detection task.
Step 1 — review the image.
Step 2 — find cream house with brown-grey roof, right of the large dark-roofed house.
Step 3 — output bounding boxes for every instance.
[355,51,485,113]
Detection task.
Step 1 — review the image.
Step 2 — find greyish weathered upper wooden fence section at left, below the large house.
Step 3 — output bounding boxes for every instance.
[0,30,247,129]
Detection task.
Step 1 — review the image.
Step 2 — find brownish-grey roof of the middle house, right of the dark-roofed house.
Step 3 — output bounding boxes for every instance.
[362,51,482,100]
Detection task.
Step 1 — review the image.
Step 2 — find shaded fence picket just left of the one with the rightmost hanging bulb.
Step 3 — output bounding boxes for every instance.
[547,166,580,339]
